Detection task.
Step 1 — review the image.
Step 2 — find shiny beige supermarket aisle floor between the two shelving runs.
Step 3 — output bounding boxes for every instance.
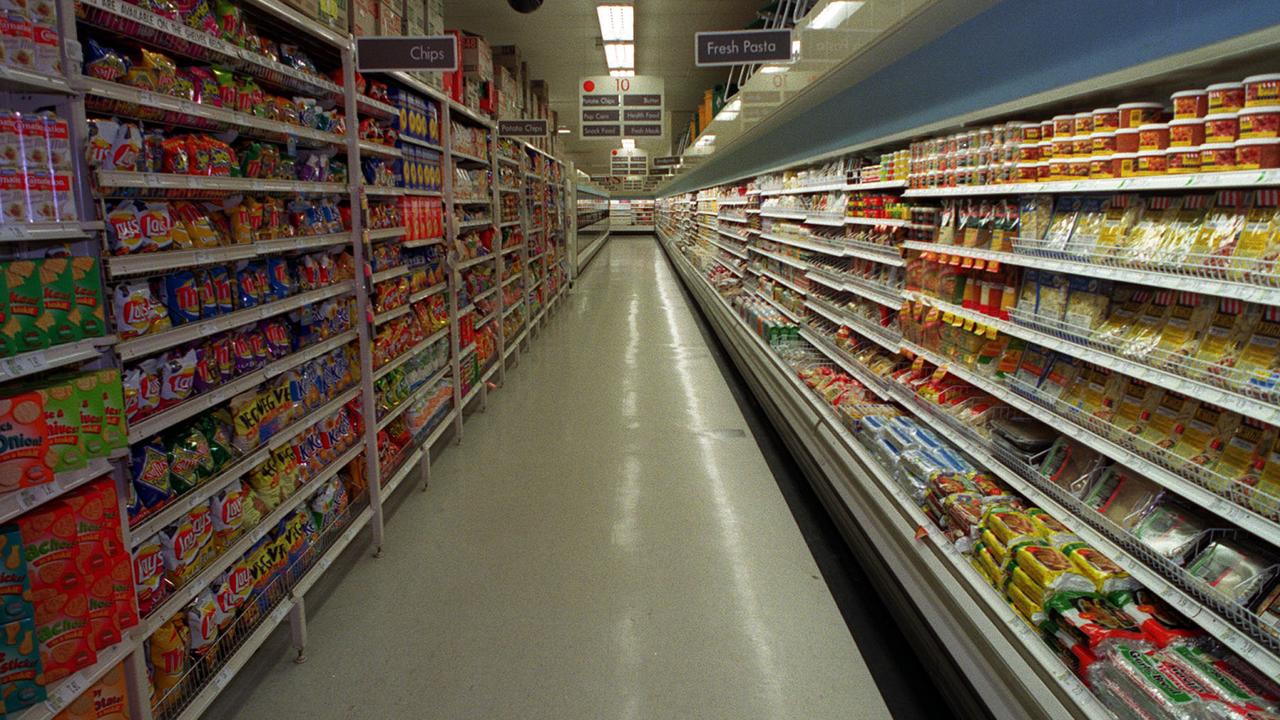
[207,237,888,720]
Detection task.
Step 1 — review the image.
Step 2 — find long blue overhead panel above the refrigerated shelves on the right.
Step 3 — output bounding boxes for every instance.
[666,0,1280,193]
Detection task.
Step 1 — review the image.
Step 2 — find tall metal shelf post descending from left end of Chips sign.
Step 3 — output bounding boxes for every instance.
[342,42,383,557]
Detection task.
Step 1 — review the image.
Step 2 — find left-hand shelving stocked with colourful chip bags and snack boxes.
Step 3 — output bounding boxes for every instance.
[0,0,576,720]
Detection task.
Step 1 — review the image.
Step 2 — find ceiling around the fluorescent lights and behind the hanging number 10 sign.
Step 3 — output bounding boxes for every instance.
[444,0,767,174]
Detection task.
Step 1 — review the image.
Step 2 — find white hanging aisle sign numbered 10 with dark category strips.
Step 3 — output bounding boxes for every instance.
[579,76,667,141]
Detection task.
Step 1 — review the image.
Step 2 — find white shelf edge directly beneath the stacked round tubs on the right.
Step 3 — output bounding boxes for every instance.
[902,170,1280,197]
